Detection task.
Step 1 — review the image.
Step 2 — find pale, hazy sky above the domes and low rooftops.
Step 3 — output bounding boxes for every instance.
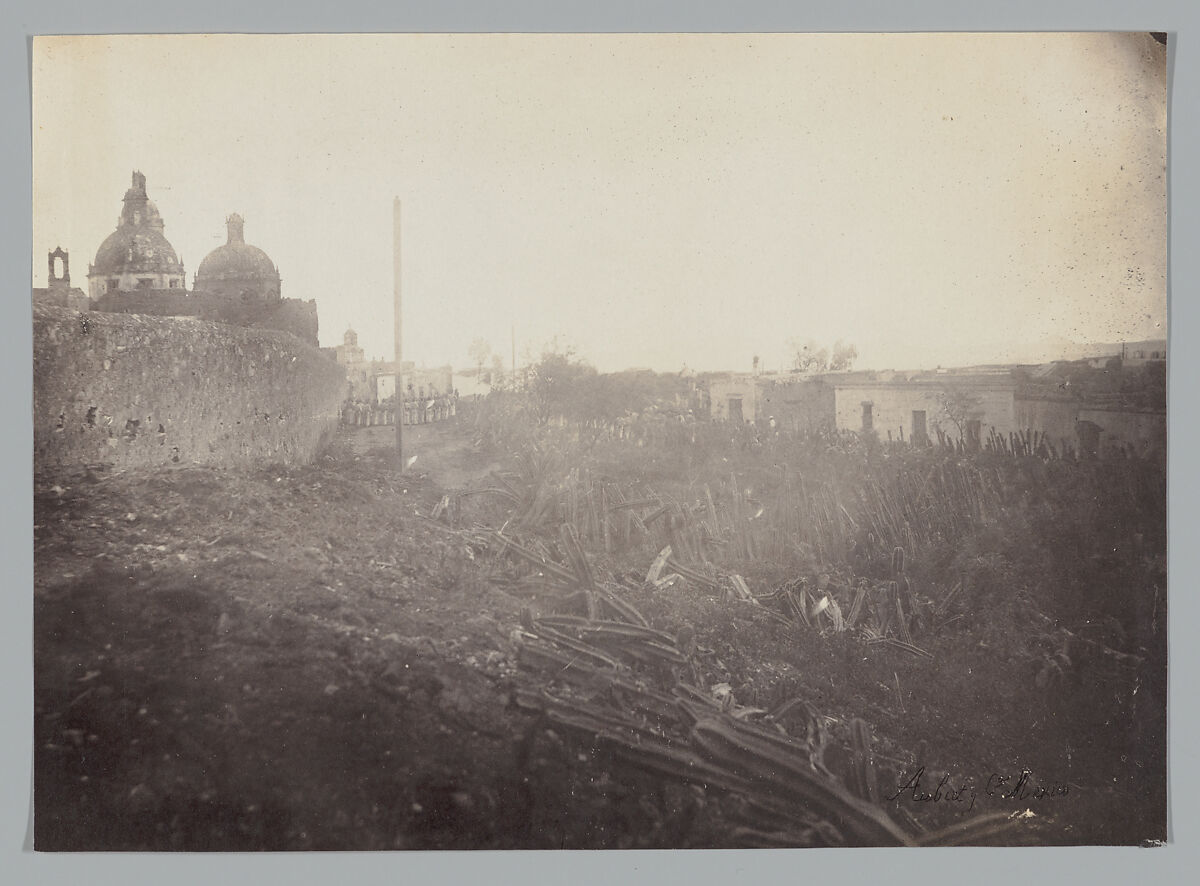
[32,34,1166,371]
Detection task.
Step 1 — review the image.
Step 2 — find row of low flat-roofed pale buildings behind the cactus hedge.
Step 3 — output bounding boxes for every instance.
[707,352,1166,454]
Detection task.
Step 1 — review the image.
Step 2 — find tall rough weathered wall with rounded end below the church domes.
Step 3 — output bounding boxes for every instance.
[34,305,346,471]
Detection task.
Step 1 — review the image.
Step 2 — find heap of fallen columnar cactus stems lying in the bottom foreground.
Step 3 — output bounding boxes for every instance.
[516,597,1021,846]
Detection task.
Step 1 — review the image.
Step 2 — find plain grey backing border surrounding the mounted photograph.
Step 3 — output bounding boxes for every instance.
[0,0,1200,884]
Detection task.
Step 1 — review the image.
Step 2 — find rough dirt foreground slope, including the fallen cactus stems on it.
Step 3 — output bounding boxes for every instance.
[35,423,1158,850]
